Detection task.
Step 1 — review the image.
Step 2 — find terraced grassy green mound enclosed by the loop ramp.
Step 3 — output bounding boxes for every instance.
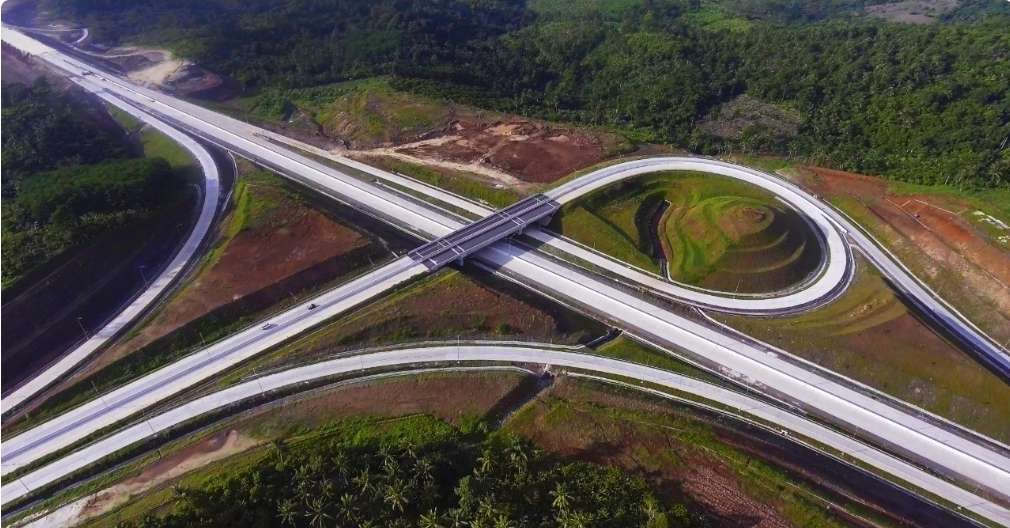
[551,173,820,293]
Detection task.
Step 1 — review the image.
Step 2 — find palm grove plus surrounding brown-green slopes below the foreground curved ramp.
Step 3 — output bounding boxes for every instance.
[65,372,891,527]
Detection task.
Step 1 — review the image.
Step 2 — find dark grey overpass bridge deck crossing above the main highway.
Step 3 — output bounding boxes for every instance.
[407,194,561,271]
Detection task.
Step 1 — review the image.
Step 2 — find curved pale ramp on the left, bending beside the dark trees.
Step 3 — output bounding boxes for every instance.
[0,93,220,413]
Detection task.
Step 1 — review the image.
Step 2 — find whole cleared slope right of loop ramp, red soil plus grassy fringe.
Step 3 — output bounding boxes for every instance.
[786,168,1010,343]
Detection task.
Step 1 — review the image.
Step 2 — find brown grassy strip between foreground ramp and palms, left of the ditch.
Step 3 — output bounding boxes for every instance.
[41,372,529,526]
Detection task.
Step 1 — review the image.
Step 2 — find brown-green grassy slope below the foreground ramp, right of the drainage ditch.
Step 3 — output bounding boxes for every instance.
[505,382,864,527]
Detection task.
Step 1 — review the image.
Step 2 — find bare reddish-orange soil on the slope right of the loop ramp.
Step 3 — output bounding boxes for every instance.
[797,168,1010,342]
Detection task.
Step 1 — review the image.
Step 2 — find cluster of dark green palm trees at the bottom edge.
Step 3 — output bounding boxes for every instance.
[120,416,708,528]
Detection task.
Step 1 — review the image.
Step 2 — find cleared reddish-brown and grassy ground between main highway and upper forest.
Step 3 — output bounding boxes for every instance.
[217,78,632,187]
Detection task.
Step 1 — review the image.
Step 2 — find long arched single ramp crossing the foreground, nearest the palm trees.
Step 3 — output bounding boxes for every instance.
[0,344,1010,524]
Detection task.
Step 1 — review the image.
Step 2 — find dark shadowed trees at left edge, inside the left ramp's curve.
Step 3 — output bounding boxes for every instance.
[2,78,181,286]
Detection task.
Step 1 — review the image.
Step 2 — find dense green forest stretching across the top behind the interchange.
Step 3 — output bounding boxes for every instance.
[46,0,1010,187]
